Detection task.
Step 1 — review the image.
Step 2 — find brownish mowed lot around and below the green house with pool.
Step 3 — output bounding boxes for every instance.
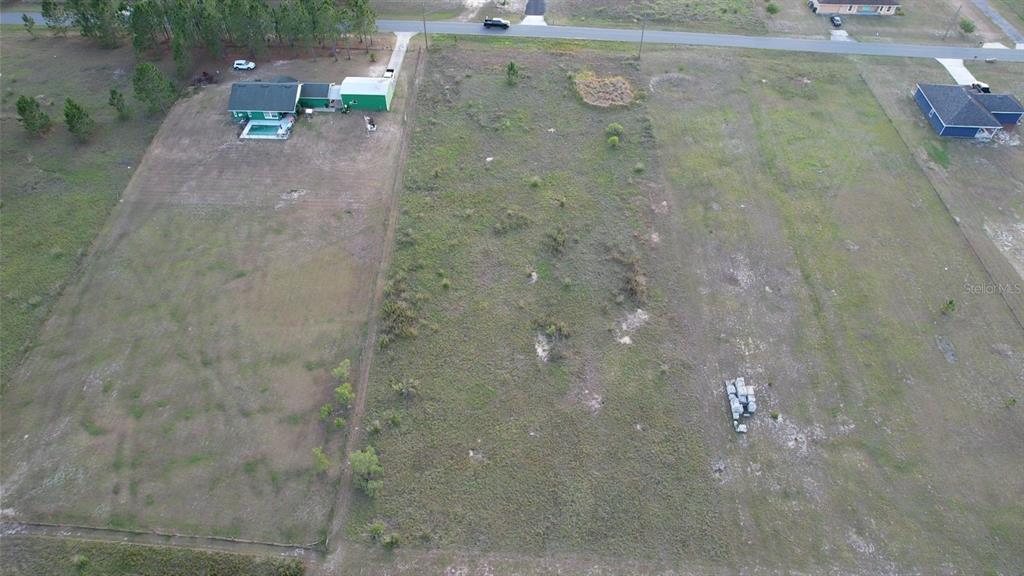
[3,53,411,543]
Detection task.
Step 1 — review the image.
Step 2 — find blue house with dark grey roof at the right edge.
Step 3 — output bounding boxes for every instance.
[913,84,1024,139]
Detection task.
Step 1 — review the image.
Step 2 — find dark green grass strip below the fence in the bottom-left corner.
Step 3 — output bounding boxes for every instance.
[0,536,305,576]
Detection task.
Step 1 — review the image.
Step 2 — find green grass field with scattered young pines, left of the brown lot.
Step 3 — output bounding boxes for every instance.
[0,32,161,385]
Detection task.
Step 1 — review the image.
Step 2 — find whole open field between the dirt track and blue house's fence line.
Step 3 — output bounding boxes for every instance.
[349,41,1024,574]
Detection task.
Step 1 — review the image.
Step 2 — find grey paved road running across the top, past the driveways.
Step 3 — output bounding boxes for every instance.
[8,12,1024,63]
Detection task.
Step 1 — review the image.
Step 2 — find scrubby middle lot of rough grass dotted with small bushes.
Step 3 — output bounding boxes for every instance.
[349,41,729,560]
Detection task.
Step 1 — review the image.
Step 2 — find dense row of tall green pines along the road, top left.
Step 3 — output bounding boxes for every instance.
[41,0,377,65]
